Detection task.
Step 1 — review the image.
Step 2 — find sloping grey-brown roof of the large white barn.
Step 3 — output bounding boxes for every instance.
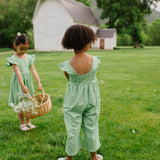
[32,0,99,26]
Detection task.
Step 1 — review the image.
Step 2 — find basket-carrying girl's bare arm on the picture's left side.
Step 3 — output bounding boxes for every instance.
[12,64,29,93]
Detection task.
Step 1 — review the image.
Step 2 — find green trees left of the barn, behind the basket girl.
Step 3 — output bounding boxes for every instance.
[0,0,36,47]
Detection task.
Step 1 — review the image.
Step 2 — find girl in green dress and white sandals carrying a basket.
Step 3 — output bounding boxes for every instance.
[7,33,42,131]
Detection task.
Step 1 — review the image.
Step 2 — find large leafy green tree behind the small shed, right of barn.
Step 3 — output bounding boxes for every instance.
[96,0,159,48]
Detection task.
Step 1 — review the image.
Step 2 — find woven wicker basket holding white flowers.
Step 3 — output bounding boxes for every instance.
[21,90,52,119]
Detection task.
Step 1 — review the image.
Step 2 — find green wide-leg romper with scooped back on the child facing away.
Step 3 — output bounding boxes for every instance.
[59,56,100,156]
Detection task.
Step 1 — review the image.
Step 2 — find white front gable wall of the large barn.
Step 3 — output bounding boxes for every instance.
[33,0,73,51]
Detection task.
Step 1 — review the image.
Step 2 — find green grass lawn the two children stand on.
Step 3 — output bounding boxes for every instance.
[0,47,160,160]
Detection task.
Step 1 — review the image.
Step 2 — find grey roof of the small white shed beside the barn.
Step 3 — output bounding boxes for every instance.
[96,29,116,38]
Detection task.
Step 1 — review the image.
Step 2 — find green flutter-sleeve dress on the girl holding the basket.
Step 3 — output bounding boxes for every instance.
[7,54,35,106]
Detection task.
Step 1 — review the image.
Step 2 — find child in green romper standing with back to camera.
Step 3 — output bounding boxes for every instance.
[59,25,103,160]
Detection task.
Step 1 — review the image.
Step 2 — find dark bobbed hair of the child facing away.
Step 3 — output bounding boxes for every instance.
[62,24,97,51]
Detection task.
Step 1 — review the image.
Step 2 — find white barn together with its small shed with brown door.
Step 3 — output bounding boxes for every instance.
[32,0,117,51]
